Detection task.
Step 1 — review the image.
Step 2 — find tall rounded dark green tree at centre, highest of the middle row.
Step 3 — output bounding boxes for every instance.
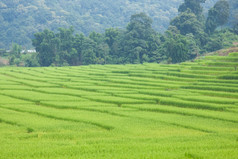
[122,13,158,63]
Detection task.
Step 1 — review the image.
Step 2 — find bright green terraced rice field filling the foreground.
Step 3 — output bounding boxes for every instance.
[0,53,238,159]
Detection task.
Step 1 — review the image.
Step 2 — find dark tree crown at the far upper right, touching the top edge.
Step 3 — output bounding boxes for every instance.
[206,0,229,34]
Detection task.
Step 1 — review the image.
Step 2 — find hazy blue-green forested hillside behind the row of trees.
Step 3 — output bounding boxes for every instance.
[0,0,217,48]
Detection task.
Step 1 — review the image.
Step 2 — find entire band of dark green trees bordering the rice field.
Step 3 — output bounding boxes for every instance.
[0,0,238,67]
